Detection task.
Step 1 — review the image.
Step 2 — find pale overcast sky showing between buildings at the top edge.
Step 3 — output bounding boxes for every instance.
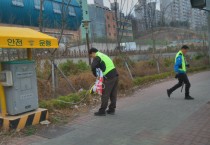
[88,0,160,13]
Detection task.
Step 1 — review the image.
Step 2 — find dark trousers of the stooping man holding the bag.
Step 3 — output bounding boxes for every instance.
[99,77,119,112]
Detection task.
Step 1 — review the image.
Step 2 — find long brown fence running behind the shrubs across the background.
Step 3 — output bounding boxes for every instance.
[0,47,208,61]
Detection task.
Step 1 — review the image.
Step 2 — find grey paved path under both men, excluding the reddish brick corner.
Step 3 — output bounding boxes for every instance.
[33,71,210,145]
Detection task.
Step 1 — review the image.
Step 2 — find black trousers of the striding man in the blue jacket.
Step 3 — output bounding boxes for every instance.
[169,73,191,96]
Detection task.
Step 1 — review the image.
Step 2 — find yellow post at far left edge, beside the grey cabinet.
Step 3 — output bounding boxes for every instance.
[0,63,7,117]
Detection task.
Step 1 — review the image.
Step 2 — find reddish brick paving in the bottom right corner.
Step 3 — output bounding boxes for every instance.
[159,103,210,145]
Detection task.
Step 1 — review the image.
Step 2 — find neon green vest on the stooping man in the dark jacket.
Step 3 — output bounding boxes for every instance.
[96,52,115,76]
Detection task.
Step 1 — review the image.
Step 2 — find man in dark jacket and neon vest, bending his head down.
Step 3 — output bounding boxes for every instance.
[89,48,118,116]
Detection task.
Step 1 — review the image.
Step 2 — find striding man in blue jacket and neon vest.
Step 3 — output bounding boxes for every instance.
[167,45,194,100]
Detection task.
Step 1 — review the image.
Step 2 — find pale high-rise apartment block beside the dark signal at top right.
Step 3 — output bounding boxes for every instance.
[160,0,207,29]
